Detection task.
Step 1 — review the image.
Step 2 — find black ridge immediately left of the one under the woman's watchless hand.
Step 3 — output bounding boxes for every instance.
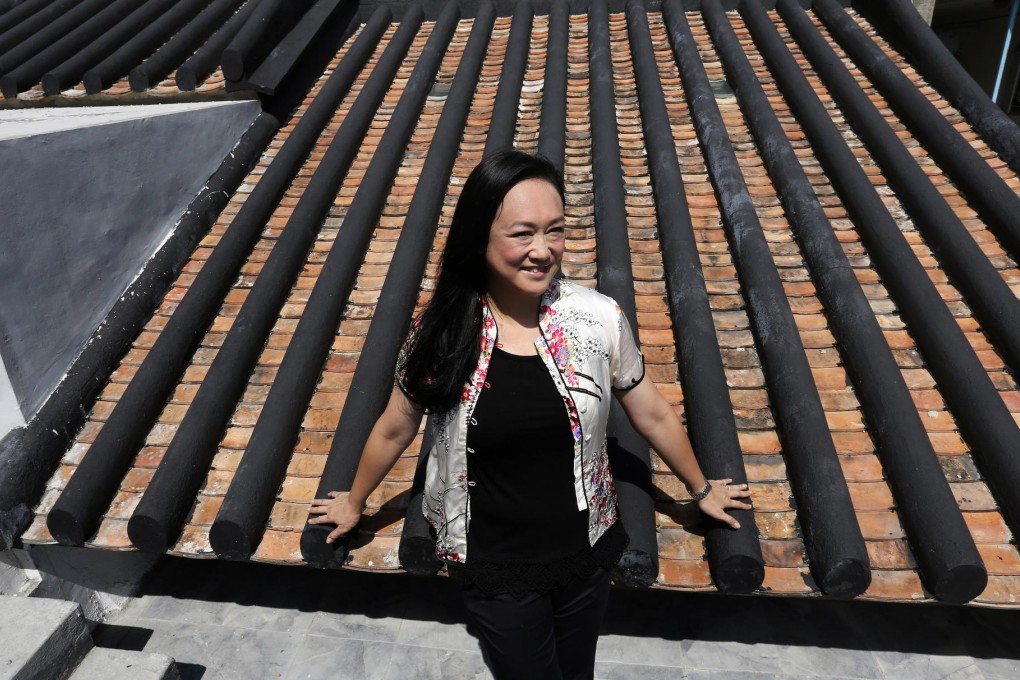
[209,3,460,560]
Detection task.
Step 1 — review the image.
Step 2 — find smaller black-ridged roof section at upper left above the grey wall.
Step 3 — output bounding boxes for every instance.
[0,0,350,106]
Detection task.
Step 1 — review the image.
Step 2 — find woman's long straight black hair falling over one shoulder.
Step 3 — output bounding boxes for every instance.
[399,151,564,413]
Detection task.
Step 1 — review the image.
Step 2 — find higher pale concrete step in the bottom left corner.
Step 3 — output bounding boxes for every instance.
[0,595,93,680]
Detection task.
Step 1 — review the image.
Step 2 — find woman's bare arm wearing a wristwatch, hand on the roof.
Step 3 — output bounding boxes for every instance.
[613,376,751,529]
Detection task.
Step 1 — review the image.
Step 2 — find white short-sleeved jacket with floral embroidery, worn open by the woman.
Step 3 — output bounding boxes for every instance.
[397,279,645,563]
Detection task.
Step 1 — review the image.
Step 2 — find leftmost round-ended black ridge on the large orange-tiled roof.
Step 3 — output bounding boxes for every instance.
[48,7,386,545]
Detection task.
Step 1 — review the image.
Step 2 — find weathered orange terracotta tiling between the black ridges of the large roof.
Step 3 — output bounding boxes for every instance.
[13,2,1020,606]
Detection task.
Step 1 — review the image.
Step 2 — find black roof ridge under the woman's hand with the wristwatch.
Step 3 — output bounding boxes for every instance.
[626,0,765,593]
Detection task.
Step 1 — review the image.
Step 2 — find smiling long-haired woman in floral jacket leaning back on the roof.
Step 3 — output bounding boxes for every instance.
[310,151,750,680]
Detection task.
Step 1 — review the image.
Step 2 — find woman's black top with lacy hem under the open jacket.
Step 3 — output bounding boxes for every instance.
[454,348,626,594]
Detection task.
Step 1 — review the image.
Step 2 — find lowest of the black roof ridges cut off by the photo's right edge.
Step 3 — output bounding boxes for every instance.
[742,2,1020,554]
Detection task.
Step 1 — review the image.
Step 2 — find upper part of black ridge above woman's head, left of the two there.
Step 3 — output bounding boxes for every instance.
[483,0,533,156]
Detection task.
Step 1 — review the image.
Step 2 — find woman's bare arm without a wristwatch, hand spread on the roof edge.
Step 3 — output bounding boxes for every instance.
[308,387,422,543]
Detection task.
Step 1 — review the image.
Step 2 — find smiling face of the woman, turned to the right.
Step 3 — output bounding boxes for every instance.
[486,179,564,300]
